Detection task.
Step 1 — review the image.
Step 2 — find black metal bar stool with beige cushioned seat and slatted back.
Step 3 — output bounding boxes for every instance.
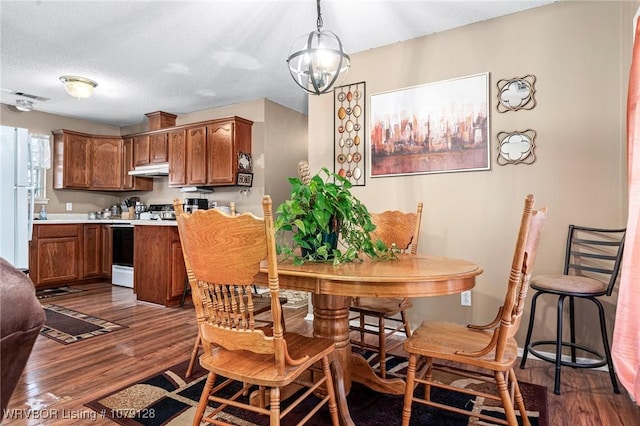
[520,225,626,395]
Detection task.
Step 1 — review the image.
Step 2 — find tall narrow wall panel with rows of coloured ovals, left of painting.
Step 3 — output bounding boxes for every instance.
[333,82,366,186]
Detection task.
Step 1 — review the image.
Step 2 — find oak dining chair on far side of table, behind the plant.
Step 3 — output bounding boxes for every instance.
[349,202,423,378]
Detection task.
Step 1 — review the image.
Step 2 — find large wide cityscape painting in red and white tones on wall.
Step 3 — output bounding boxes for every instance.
[369,72,491,178]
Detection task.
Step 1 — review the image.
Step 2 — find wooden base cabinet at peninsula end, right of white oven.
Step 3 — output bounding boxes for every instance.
[133,225,187,306]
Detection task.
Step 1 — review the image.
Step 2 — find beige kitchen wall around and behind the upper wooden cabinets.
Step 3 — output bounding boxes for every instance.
[0,99,307,215]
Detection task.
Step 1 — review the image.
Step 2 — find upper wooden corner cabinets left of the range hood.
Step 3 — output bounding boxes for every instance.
[53,130,153,191]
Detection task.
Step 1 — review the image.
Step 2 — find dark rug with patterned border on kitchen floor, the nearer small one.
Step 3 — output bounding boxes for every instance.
[40,304,127,345]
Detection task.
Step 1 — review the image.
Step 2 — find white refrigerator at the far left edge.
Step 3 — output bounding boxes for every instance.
[0,126,34,269]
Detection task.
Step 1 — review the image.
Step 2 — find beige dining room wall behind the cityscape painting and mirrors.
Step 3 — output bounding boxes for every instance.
[309,1,638,352]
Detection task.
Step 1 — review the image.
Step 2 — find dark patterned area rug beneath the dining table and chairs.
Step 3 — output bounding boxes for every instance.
[85,357,548,426]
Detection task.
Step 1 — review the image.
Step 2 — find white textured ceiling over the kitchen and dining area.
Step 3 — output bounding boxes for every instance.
[0,0,552,126]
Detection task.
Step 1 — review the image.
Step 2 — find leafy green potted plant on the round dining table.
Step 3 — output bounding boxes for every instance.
[275,162,394,265]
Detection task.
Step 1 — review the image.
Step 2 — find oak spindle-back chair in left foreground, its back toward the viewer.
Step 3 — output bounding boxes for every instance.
[177,195,338,425]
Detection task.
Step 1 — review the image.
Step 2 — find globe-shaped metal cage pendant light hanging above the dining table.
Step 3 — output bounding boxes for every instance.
[287,0,351,95]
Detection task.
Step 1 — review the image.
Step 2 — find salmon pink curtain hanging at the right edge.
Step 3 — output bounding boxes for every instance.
[612,15,640,404]
